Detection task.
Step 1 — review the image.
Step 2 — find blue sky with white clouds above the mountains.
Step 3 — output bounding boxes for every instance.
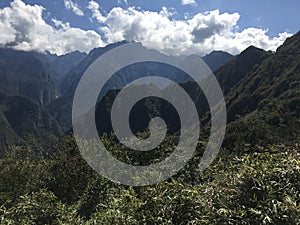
[0,0,300,56]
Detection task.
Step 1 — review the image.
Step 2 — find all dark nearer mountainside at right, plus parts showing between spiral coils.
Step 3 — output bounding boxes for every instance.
[91,33,300,145]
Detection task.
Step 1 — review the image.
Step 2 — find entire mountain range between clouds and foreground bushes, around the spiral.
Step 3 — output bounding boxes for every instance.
[0,32,300,155]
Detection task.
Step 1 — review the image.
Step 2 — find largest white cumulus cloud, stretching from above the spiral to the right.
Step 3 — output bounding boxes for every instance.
[90,1,291,55]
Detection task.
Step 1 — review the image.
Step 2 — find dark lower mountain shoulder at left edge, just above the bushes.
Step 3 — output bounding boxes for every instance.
[0,90,63,156]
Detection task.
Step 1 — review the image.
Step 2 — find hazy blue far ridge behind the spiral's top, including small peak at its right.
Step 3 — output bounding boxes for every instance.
[47,41,233,131]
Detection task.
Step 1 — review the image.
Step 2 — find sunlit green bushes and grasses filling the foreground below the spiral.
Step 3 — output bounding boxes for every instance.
[0,136,300,224]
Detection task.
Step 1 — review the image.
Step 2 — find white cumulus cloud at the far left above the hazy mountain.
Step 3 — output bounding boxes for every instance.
[0,0,104,55]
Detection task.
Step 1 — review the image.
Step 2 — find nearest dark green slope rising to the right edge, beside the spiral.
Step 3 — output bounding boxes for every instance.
[225,32,300,146]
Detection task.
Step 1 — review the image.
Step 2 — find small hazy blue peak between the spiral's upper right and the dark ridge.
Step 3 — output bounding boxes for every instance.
[202,51,234,72]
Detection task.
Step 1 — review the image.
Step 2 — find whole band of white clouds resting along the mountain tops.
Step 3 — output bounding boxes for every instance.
[0,0,291,55]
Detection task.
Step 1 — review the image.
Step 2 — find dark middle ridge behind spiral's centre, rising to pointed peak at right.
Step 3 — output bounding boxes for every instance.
[87,47,271,135]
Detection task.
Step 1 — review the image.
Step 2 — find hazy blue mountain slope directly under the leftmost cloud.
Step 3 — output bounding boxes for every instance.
[0,49,56,105]
